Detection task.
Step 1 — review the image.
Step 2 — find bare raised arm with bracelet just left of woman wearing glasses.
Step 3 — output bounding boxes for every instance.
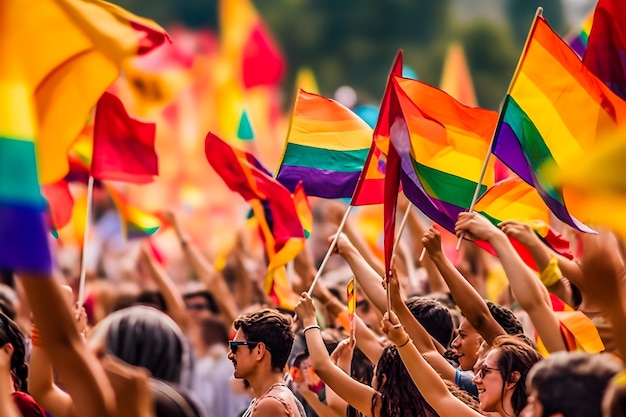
[382,312,482,417]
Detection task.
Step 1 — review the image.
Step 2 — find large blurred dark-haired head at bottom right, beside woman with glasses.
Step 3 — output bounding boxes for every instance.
[526,352,620,417]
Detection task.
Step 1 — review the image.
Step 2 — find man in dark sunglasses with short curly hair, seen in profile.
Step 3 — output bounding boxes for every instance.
[228,308,306,417]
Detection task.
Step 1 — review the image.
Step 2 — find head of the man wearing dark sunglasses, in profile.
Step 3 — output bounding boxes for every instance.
[228,308,294,378]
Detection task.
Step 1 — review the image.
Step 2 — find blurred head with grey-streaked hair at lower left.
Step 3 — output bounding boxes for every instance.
[89,306,191,386]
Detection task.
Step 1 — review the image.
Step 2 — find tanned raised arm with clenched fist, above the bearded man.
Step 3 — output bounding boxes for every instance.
[422,227,506,344]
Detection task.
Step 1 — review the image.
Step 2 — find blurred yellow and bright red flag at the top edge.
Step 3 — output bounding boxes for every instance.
[219,0,285,88]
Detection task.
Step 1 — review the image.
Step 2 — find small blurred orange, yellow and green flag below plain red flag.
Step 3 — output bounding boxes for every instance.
[106,183,161,239]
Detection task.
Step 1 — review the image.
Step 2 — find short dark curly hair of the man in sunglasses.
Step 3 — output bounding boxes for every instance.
[234,308,294,371]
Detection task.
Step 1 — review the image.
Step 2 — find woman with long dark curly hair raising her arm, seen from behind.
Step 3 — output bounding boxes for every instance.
[296,293,480,417]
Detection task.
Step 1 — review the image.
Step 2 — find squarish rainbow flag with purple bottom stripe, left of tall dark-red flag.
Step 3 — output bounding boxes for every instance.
[276,90,372,198]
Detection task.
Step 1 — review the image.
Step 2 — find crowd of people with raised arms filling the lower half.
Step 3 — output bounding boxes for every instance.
[0,196,626,417]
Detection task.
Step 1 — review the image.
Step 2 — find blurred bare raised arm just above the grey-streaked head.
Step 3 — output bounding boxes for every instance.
[141,244,189,331]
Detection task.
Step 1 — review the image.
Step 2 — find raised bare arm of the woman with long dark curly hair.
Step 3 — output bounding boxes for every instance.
[296,293,379,417]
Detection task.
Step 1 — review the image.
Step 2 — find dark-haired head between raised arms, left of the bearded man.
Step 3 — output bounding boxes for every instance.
[406,297,454,348]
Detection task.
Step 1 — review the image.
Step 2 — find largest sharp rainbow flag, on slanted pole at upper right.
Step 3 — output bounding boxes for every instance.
[493,17,626,232]
